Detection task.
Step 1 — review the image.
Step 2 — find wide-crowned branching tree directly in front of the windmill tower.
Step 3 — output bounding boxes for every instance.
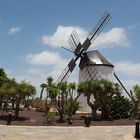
[84,80,118,118]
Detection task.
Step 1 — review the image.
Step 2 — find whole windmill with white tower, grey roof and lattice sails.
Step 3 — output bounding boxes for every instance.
[41,11,131,112]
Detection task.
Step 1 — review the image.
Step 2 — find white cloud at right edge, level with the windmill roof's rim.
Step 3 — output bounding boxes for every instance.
[115,61,140,78]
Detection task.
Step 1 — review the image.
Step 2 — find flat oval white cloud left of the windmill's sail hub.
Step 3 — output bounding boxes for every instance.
[25,51,65,65]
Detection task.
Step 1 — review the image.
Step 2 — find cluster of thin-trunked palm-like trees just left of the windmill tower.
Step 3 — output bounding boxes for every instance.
[57,82,81,123]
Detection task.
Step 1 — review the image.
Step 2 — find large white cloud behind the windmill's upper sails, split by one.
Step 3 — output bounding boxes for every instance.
[41,26,130,48]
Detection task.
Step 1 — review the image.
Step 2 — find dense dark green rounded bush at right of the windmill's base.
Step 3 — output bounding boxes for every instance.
[100,95,133,119]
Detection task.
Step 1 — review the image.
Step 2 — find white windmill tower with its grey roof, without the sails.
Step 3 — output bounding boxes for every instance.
[78,50,114,112]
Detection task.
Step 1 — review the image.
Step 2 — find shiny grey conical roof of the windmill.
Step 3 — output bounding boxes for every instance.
[86,50,113,67]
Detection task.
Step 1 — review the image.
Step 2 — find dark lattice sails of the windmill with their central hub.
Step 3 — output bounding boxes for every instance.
[56,11,111,84]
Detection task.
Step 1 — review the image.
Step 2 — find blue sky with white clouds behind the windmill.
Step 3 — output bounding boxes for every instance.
[0,0,140,94]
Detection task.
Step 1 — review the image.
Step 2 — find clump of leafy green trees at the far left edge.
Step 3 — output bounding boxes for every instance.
[0,68,36,117]
